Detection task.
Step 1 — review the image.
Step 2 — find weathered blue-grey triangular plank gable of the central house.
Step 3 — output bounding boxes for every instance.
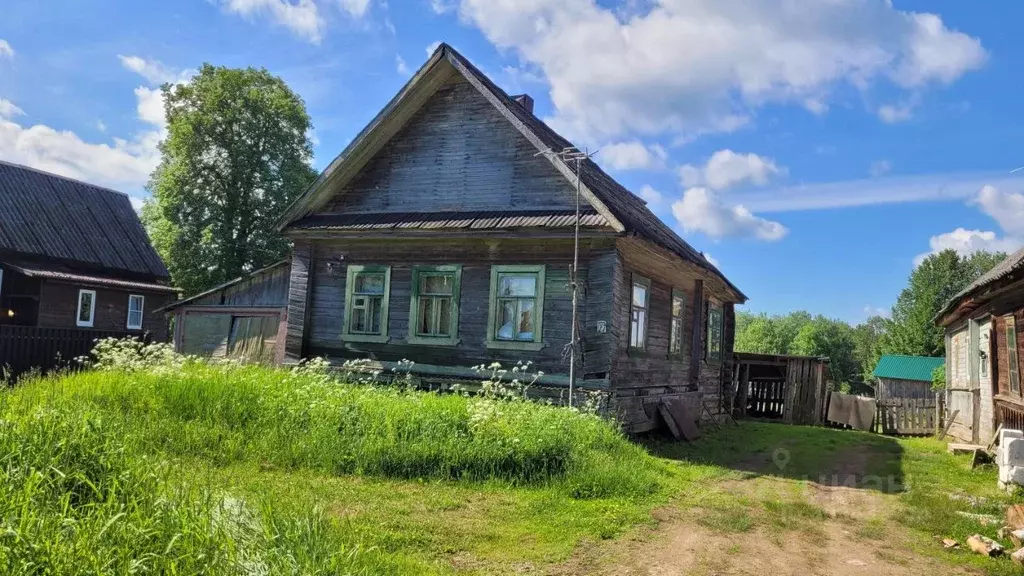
[319,76,575,214]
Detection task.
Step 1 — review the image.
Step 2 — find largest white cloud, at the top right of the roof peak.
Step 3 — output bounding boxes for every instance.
[452,0,986,140]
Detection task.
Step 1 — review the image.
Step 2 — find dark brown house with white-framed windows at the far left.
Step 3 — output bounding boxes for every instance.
[0,162,176,338]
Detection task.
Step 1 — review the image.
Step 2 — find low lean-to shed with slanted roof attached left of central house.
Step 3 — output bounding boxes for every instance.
[156,260,291,363]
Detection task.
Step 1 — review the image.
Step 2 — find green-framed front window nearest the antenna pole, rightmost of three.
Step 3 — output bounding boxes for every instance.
[486,265,545,349]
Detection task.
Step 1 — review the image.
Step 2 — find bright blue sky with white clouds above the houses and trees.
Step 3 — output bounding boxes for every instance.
[0,0,1024,322]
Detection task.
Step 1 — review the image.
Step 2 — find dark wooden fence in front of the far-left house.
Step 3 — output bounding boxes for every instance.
[0,326,129,379]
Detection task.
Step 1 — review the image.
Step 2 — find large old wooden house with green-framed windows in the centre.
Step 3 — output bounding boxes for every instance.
[279,44,746,431]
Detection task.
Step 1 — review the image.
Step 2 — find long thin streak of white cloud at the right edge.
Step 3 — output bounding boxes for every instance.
[729,172,1024,213]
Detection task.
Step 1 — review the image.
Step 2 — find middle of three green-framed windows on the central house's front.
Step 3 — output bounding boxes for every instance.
[409,264,462,345]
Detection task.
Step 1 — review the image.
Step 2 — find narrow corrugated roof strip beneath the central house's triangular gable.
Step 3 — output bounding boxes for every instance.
[292,210,608,231]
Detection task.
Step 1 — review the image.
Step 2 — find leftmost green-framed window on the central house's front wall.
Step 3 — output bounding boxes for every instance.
[342,264,391,342]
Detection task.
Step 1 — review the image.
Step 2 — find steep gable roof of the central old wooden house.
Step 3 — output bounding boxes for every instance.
[276,44,746,302]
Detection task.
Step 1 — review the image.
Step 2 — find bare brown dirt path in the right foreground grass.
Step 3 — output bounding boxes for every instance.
[555,451,970,576]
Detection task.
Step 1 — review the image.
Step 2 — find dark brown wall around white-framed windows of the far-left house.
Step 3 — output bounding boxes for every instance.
[38,281,174,342]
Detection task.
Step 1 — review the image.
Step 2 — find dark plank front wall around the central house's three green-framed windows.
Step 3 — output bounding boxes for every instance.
[290,235,612,377]
